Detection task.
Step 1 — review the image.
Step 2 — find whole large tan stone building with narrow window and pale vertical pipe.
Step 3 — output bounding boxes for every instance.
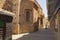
[0,0,43,34]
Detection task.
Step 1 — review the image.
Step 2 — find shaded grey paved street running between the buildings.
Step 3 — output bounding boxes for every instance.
[17,29,57,40]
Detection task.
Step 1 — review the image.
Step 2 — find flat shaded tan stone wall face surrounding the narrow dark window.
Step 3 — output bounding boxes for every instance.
[19,0,34,33]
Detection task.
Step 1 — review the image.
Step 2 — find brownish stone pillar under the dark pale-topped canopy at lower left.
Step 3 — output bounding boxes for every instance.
[5,23,12,40]
